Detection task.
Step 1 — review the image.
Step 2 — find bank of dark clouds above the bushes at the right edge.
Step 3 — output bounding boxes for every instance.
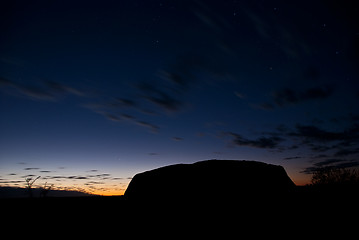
[246,121,359,174]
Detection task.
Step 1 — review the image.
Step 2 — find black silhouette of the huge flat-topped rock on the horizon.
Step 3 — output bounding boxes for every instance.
[125,160,295,201]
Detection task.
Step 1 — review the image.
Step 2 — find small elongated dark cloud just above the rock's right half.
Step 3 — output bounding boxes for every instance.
[227,132,283,149]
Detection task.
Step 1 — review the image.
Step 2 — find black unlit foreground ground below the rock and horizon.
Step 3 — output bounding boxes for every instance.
[0,187,359,239]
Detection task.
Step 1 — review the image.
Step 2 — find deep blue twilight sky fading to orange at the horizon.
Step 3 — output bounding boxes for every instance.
[0,0,359,195]
